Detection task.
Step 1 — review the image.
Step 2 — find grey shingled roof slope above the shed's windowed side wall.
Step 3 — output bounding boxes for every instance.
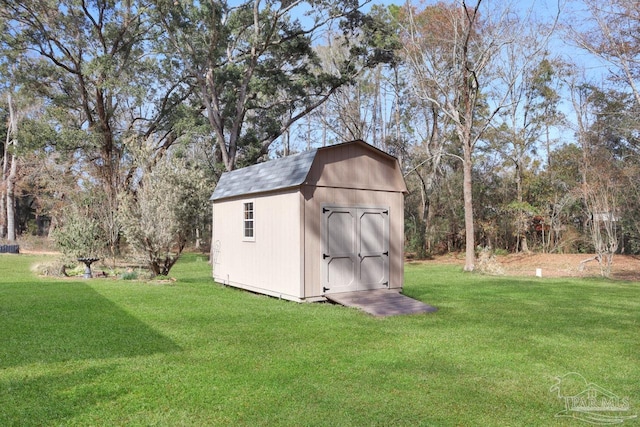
[211,149,318,200]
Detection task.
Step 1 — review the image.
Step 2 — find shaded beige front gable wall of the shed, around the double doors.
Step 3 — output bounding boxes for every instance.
[302,143,407,299]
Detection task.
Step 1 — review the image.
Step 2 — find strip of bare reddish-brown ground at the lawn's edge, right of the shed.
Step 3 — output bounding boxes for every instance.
[424,254,640,281]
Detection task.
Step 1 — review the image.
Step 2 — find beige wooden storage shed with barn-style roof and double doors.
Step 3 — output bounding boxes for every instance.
[211,140,407,301]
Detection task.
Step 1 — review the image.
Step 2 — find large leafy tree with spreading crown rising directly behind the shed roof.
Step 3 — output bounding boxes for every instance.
[155,0,388,170]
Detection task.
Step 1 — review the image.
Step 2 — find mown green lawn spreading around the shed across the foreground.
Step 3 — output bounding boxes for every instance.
[0,255,640,426]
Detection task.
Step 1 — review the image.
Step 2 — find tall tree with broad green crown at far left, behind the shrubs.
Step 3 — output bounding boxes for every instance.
[0,0,188,250]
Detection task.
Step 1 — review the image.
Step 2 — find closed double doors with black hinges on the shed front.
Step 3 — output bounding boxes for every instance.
[322,207,389,293]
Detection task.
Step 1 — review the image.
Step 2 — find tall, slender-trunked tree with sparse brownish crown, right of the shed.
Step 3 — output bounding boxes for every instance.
[402,0,549,271]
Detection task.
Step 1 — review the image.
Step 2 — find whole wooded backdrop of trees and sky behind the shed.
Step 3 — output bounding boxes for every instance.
[0,0,640,274]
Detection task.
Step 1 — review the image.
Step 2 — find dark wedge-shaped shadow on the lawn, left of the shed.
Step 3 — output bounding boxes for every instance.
[0,282,180,368]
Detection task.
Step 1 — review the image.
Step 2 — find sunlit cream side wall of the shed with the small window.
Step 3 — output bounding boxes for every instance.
[213,188,304,301]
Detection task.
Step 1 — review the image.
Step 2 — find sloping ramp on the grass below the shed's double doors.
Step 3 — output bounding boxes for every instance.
[325,289,438,317]
